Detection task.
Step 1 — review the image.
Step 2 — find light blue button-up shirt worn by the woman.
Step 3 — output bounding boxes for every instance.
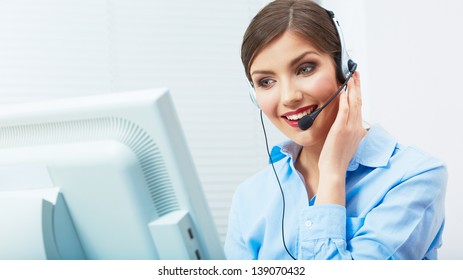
[225,126,447,259]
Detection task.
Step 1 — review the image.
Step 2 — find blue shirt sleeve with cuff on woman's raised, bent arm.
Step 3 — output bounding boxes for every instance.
[298,158,447,259]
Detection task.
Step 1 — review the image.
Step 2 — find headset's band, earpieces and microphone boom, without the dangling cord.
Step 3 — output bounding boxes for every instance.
[249,10,357,130]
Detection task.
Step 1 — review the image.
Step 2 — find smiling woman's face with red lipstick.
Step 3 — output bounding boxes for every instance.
[250,31,340,147]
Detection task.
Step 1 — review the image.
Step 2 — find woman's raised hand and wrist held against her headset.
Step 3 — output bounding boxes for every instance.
[316,72,366,205]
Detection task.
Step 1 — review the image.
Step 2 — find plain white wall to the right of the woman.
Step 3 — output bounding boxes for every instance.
[323,0,463,259]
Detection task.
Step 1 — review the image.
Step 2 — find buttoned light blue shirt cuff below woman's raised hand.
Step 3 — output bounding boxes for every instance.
[299,204,346,241]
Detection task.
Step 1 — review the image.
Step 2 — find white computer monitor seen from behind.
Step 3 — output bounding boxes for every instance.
[0,89,224,260]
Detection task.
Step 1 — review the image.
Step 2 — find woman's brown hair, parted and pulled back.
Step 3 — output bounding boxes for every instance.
[241,0,344,81]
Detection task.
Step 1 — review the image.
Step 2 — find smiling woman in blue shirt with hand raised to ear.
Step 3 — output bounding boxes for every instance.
[225,0,447,259]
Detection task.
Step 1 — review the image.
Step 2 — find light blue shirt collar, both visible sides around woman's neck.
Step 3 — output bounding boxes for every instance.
[269,125,397,171]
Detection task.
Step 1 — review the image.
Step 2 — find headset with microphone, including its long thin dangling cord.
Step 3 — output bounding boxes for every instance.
[254,10,357,260]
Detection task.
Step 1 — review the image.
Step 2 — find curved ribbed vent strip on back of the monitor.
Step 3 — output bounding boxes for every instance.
[0,117,180,216]
